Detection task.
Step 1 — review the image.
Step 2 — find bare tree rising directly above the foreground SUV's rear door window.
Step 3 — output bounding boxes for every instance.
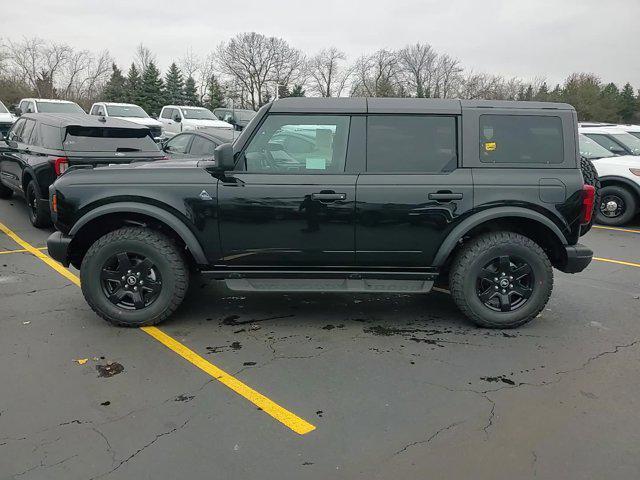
[398,43,438,98]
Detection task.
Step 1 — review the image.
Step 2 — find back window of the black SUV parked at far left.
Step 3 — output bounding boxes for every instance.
[62,126,158,152]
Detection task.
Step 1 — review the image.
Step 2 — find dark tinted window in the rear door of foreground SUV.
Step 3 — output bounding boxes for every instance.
[367,115,458,173]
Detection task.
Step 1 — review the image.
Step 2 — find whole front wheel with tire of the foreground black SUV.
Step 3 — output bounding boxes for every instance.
[80,227,189,327]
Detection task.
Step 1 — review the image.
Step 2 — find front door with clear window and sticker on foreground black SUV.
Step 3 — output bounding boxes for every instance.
[218,114,357,268]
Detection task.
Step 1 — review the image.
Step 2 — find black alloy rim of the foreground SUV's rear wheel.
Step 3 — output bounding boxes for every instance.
[476,255,535,312]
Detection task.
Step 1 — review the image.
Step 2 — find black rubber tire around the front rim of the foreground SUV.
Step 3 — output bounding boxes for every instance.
[80,227,189,327]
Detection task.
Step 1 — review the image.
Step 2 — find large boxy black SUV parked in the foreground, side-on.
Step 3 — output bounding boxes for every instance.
[48,98,594,328]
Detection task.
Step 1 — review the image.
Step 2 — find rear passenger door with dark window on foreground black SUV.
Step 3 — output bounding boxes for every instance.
[356,113,473,267]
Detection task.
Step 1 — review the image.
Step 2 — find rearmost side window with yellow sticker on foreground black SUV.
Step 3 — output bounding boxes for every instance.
[480,115,564,164]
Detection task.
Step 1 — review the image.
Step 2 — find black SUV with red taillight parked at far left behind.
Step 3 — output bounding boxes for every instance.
[0,113,165,227]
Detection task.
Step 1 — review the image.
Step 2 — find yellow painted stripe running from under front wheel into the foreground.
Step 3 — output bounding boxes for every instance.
[142,327,316,435]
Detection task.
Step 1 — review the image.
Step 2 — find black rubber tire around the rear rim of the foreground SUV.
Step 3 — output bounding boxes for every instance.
[449,231,553,328]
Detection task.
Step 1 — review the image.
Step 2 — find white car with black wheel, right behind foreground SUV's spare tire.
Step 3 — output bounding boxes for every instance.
[579,134,640,225]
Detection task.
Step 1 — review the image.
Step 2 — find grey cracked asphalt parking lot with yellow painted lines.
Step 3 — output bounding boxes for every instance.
[0,199,640,480]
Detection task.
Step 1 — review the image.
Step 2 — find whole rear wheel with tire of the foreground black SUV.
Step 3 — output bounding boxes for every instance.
[449,232,553,328]
